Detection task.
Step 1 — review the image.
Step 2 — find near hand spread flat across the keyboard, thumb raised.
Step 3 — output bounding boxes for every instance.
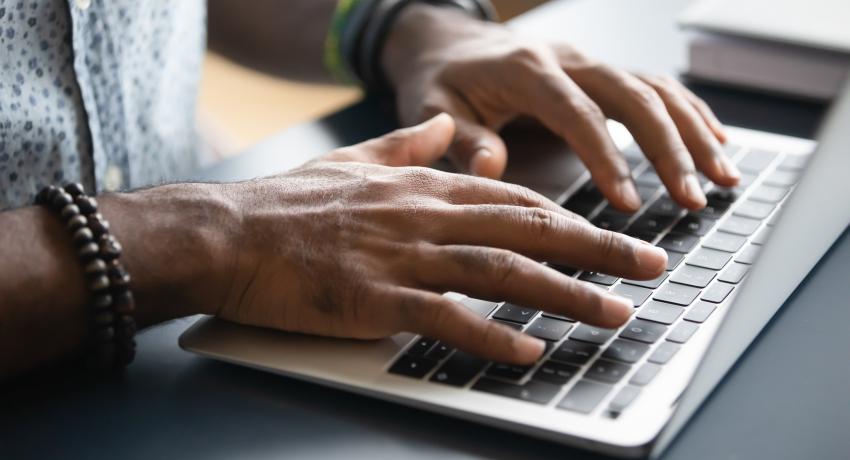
[214,114,666,363]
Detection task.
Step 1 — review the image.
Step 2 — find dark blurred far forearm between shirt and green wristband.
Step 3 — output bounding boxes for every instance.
[208,0,337,82]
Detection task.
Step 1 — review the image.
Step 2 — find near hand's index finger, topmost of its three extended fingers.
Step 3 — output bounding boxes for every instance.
[429,205,667,279]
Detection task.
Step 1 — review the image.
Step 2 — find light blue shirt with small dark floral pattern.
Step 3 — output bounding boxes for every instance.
[0,0,206,210]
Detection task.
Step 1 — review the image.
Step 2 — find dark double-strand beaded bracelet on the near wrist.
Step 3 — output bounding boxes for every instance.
[35,183,136,370]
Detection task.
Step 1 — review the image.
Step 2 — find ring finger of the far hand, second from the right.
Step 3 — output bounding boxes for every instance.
[640,77,741,187]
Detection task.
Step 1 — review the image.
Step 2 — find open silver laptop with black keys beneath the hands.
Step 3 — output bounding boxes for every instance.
[180,88,850,457]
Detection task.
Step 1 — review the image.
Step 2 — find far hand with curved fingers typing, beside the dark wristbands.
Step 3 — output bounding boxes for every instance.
[383,5,739,211]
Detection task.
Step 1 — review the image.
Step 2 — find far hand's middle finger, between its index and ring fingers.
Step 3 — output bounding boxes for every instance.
[571,65,706,209]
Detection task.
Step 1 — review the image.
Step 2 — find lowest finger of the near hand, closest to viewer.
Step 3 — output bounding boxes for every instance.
[396,288,545,364]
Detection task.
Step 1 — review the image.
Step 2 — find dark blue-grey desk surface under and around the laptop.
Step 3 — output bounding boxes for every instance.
[0,0,850,459]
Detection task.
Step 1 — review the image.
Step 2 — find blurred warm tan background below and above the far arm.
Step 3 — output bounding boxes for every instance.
[198,0,547,158]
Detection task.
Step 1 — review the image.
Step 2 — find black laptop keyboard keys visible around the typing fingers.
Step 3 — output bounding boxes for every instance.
[388,145,807,417]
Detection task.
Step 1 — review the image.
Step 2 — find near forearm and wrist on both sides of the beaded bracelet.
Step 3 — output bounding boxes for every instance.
[0,181,234,380]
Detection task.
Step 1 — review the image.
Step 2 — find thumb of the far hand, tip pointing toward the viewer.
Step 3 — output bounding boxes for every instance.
[450,118,508,179]
